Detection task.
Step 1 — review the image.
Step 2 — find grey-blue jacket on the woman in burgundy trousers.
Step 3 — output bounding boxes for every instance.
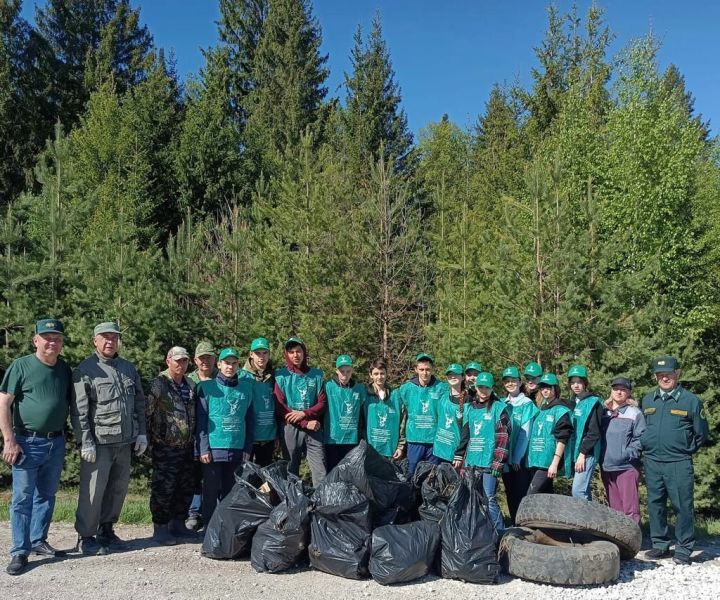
[600,404,645,471]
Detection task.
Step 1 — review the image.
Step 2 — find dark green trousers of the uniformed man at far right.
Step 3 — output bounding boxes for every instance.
[644,457,695,556]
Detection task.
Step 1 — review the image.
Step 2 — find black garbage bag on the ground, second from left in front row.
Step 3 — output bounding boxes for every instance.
[250,467,311,573]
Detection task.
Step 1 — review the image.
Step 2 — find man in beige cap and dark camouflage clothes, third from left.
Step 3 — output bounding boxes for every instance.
[147,346,196,545]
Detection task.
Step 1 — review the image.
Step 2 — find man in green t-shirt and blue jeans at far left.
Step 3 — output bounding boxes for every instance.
[0,319,72,575]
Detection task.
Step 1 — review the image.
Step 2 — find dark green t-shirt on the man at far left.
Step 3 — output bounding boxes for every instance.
[0,354,72,433]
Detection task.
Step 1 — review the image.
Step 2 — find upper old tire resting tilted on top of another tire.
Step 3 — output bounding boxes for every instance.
[515,494,642,560]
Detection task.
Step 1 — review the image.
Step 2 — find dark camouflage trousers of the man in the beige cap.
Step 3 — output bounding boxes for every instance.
[150,445,195,525]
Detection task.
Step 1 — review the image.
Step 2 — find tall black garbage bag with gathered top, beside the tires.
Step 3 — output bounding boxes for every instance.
[440,469,500,583]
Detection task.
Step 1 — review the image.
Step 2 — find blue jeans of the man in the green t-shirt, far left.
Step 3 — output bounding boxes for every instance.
[10,435,65,556]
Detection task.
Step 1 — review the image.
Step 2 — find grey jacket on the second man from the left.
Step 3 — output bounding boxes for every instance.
[70,352,145,446]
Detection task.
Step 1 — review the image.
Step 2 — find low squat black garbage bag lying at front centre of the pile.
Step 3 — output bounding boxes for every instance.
[370,521,440,585]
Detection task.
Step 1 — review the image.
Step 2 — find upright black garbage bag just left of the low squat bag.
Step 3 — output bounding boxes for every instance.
[308,480,372,579]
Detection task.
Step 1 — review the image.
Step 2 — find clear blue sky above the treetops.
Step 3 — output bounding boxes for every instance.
[23,0,720,134]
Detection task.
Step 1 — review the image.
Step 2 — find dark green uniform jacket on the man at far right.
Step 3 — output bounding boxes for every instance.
[640,386,708,462]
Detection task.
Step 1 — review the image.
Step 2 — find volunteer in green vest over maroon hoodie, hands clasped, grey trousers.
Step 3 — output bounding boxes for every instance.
[274,337,327,487]
